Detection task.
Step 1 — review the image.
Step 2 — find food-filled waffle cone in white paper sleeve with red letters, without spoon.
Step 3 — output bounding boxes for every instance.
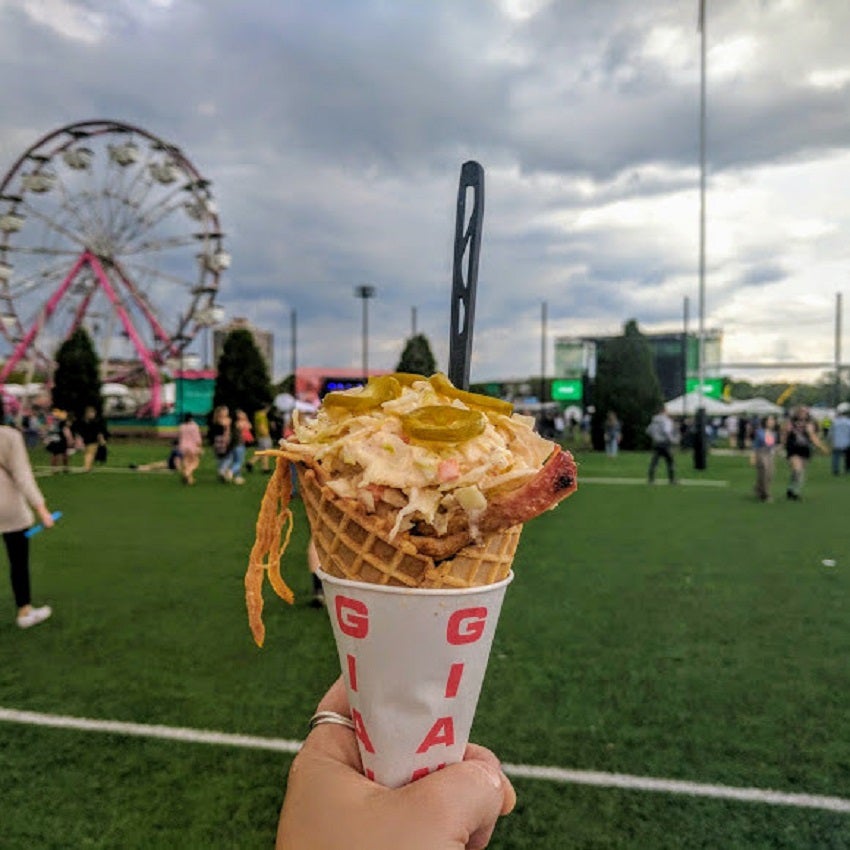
[245,374,577,785]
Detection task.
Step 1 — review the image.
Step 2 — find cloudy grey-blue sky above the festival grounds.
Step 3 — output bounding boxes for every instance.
[0,0,850,380]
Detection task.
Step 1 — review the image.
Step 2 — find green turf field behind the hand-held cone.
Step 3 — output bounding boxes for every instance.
[0,442,850,850]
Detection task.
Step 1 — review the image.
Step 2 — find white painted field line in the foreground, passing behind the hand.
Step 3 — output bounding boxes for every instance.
[0,708,850,814]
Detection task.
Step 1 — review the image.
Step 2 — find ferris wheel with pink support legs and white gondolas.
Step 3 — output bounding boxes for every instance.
[0,121,230,416]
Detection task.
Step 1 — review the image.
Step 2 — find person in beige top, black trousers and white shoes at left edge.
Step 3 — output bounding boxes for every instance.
[0,401,54,629]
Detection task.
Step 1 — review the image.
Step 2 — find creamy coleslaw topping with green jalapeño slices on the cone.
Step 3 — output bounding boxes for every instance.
[279,374,553,538]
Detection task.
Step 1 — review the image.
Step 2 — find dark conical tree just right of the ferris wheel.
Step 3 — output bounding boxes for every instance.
[213,328,272,418]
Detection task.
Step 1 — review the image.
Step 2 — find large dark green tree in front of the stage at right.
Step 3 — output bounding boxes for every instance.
[591,319,664,449]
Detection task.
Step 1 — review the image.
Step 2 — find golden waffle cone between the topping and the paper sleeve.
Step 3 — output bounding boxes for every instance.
[297,463,522,588]
